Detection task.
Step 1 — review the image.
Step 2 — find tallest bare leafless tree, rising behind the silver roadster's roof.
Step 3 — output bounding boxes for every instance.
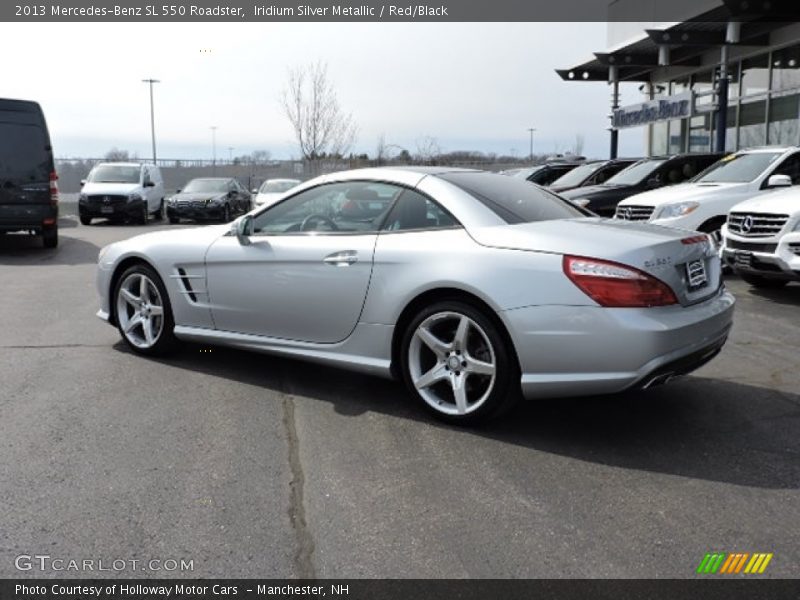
[281,62,357,160]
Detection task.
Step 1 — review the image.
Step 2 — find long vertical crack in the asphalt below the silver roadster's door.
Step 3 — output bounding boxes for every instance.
[283,395,316,579]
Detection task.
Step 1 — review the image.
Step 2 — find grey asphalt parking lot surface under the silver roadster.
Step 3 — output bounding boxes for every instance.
[0,217,800,578]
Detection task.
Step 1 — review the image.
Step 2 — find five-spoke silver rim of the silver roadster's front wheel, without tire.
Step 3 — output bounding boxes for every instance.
[117,273,164,349]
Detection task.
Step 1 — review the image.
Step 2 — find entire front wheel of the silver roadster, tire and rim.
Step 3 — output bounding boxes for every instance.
[113,264,177,356]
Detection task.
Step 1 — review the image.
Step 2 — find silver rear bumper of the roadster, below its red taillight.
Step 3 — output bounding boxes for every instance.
[501,290,735,398]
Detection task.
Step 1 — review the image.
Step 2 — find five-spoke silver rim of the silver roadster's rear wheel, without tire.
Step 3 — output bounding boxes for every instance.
[408,311,497,416]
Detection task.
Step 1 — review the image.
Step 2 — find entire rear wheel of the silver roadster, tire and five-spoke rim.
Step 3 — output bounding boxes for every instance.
[403,301,519,422]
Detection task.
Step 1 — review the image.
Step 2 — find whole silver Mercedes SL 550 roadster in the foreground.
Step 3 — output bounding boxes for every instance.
[97,168,734,422]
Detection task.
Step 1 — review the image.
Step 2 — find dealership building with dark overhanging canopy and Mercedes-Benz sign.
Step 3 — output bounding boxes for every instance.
[557,0,800,157]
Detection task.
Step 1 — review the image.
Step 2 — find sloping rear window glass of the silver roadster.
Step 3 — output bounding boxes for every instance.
[439,173,590,224]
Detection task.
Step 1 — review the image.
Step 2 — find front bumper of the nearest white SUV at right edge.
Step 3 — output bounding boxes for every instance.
[721,231,800,280]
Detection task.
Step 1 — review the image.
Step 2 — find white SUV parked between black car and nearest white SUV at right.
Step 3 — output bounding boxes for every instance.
[616,147,800,241]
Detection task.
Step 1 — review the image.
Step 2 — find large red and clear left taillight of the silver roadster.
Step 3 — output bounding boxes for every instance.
[563,256,678,308]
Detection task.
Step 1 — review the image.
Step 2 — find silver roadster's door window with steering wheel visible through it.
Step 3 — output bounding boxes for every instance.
[253,181,403,235]
